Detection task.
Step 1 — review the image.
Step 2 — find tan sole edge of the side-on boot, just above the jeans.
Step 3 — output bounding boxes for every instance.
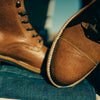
[0,55,40,73]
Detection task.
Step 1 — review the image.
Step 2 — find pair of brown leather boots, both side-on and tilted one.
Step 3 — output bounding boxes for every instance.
[0,0,100,87]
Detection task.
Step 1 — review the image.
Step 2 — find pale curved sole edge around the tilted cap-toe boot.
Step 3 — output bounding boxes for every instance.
[47,0,96,88]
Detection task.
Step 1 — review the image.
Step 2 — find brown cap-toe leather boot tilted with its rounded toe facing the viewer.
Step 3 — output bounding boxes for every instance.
[47,0,100,87]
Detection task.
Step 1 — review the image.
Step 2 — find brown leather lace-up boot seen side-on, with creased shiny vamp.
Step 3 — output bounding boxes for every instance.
[0,0,47,73]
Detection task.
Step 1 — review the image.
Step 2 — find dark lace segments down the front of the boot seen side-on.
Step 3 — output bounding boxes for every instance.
[16,1,43,43]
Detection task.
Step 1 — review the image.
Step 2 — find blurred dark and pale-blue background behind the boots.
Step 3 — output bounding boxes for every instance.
[25,0,100,94]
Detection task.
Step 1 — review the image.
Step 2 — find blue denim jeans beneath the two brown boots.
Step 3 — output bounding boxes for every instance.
[0,64,96,100]
